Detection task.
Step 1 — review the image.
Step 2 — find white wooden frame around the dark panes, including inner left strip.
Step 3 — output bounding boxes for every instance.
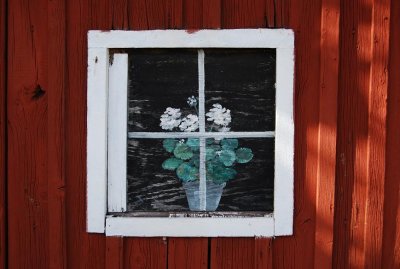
[87,29,294,237]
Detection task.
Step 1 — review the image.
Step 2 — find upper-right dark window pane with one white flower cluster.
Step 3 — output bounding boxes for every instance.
[205,49,276,132]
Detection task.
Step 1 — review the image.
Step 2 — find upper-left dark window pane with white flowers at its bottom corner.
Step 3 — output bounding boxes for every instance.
[128,49,198,132]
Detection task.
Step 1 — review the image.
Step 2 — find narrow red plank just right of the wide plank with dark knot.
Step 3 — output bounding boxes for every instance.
[47,0,67,268]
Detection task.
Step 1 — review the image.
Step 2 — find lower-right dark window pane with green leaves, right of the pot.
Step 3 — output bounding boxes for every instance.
[206,138,274,211]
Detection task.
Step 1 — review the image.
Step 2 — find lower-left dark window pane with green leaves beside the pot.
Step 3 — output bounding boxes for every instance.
[127,139,194,211]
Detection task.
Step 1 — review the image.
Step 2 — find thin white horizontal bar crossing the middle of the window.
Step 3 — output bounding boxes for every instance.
[128,131,275,138]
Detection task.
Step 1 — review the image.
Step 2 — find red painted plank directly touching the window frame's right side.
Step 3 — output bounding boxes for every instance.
[273,0,321,268]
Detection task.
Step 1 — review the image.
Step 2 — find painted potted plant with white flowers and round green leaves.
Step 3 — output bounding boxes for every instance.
[160,96,253,211]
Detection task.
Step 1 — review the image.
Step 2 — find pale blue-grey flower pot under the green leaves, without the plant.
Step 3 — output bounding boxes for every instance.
[182,180,226,211]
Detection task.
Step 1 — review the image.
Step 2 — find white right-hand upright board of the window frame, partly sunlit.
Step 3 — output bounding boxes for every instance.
[274,48,294,236]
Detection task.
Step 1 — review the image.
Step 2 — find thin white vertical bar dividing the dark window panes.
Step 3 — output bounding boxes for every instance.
[198,49,207,211]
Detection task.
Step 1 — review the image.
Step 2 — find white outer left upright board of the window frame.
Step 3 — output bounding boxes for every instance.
[87,48,108,233]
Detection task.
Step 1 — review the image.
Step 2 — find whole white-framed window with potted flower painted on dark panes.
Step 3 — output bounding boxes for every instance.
[87,29,294,236]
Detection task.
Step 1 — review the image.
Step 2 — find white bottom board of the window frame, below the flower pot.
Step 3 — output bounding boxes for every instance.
[106,216,274,237]
